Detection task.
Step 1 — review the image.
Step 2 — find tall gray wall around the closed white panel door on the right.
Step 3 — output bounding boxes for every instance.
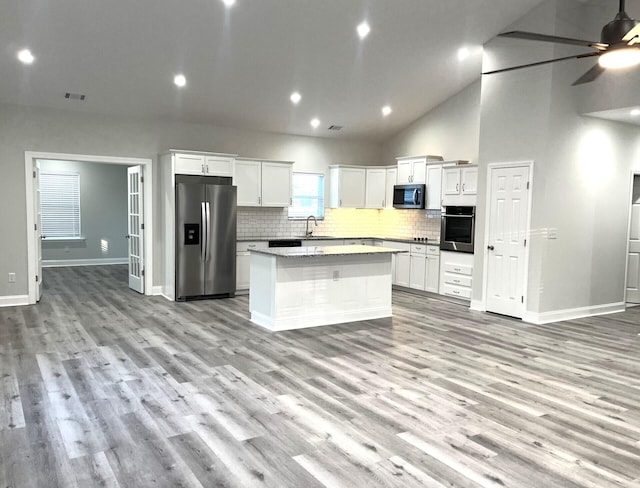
[473,0,640,314]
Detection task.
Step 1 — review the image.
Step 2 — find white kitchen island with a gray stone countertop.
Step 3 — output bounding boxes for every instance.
[249,246,402,331]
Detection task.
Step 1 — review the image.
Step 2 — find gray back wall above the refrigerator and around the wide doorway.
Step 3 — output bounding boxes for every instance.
[0,104,380,297]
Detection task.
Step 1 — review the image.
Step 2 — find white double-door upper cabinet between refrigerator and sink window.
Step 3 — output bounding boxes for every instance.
[234,159,293,207]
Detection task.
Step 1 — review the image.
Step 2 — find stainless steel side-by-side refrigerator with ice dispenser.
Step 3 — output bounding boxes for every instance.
[176,175,237,300]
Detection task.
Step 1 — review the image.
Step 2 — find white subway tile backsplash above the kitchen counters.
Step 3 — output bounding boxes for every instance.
[238,207,440,241]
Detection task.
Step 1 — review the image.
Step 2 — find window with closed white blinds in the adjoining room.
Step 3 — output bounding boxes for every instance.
[40,171,83,240]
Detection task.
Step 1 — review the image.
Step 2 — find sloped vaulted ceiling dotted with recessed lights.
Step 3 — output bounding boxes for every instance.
[0,0,588,141]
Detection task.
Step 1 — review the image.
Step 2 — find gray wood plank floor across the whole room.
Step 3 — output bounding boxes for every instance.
[0,266,640,488]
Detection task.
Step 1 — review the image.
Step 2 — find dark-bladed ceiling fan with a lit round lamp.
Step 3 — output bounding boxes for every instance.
[482,0,640,86]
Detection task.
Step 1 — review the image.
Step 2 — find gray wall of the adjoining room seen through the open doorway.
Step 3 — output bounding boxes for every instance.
[40,160,128,264]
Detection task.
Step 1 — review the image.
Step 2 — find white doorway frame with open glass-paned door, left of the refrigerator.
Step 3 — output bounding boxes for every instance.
[25,151,153,304]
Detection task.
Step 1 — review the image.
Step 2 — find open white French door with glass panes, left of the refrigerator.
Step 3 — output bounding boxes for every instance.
[127,166,144,293]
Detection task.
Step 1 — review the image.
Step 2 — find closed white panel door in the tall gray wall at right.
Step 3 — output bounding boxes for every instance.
[487,166,529,318]
